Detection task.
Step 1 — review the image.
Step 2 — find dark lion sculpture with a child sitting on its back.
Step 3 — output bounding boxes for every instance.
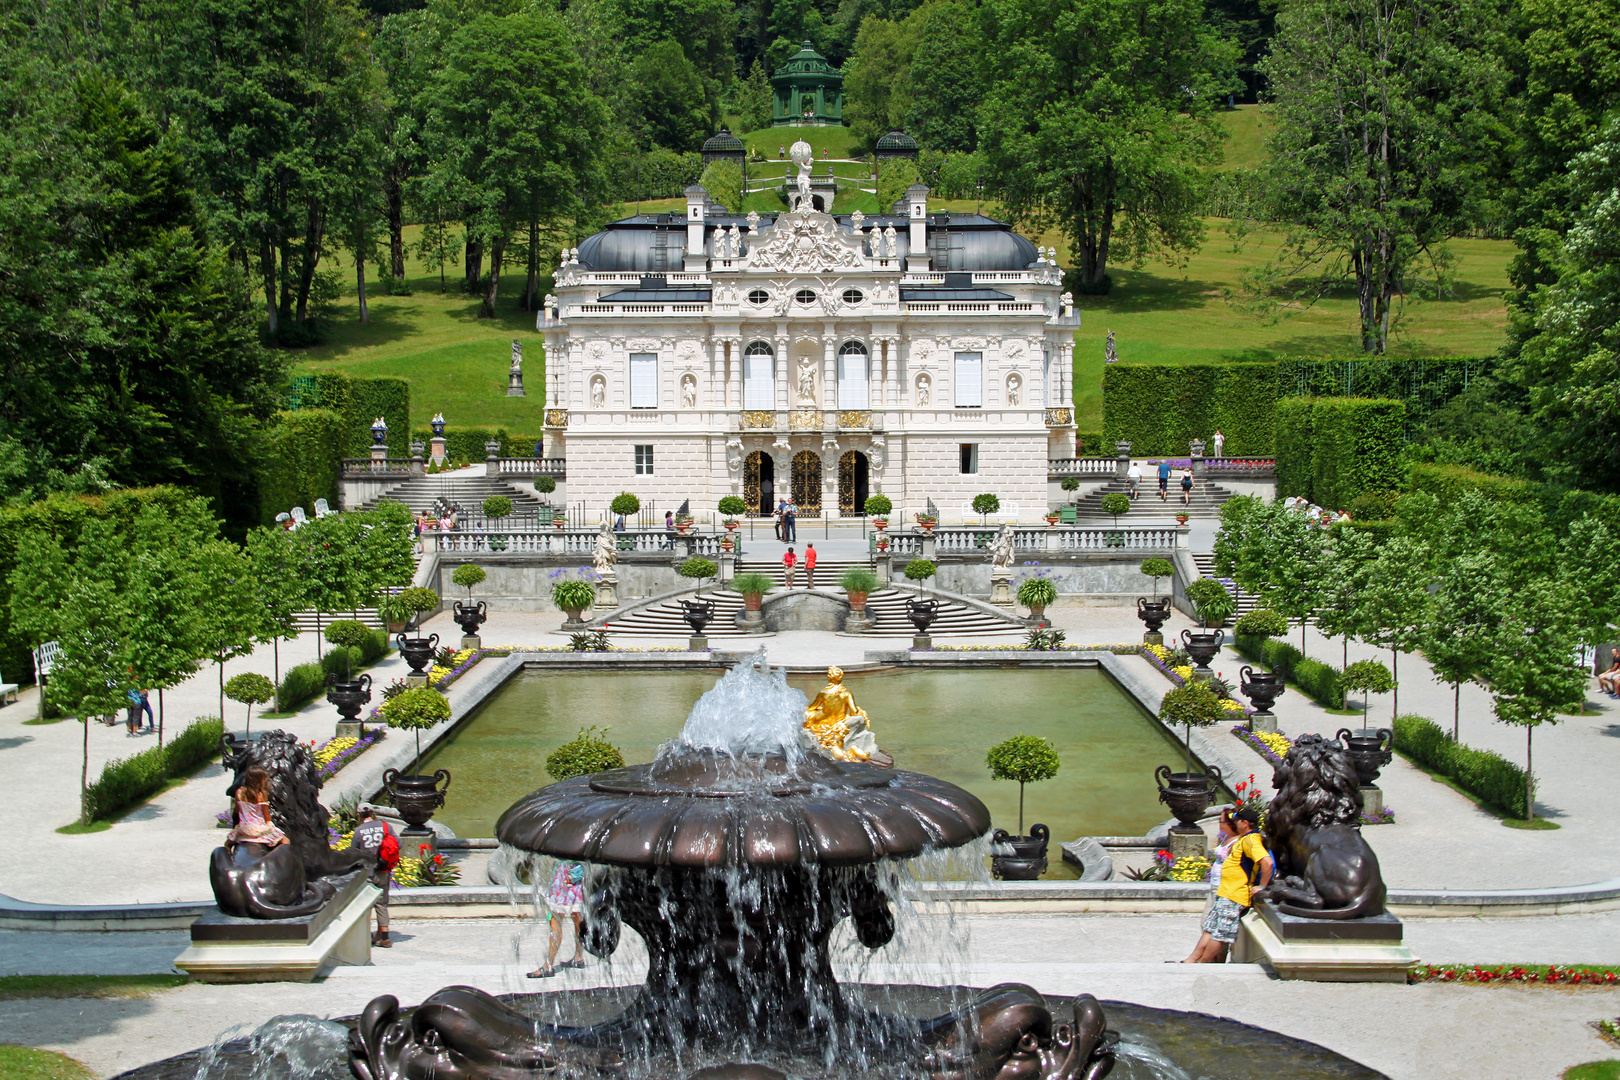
[209,730,366,918]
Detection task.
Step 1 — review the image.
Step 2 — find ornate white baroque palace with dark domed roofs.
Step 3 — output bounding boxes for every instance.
[538,144,1079,517]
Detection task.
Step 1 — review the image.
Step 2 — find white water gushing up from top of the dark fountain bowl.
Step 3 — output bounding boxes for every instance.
[658,649,810,766]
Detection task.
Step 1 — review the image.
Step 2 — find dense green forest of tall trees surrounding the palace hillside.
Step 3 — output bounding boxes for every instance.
[0,0,1620,514]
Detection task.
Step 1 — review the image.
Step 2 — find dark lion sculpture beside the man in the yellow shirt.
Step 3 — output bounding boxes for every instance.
[1256,735,1385,918]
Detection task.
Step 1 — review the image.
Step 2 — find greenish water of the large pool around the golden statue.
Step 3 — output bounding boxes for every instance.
[424,669,1181,876]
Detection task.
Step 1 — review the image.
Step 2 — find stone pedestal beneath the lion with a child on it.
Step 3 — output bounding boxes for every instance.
[175,871,382,983]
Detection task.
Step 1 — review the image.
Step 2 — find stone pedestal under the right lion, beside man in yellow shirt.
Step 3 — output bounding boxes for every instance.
[1231,900,1418,983]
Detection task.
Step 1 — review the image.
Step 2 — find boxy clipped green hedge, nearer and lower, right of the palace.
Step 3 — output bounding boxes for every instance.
[1277,397,1406,510]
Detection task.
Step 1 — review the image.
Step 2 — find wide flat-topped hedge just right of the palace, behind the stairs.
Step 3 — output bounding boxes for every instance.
[1103,364,1280,457]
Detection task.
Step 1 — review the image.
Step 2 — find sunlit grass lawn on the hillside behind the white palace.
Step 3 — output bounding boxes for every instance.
[295,202,1513,434]
